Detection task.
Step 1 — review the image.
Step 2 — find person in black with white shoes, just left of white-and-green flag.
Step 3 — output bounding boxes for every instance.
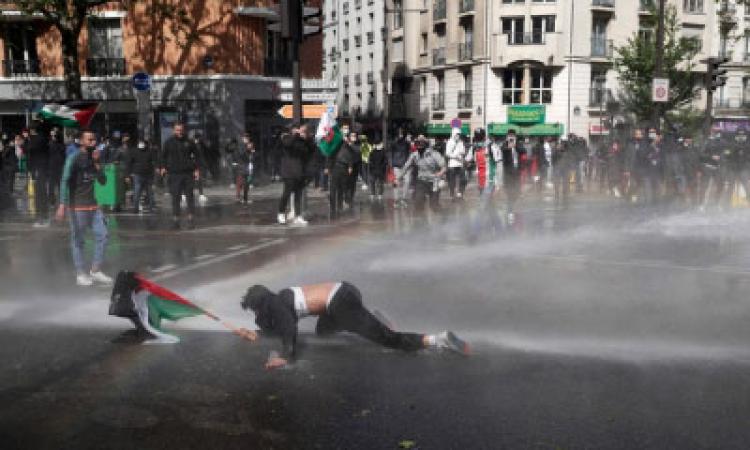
[277,125,309,225]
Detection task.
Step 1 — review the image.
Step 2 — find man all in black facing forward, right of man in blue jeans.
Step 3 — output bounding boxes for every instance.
[161,122,203,229]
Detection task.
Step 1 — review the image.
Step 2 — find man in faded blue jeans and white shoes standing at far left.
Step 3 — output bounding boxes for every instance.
[56,130,112,286]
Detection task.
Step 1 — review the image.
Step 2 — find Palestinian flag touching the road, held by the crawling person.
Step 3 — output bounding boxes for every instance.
[109,271,207,344]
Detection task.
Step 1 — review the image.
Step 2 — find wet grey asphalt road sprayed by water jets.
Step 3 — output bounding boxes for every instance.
[0,185,750,449]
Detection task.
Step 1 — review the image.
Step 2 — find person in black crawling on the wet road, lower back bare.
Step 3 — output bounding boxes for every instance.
[239,281,470,369]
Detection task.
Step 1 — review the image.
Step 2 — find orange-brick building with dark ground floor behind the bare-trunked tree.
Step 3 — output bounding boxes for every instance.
[0,0,332,151]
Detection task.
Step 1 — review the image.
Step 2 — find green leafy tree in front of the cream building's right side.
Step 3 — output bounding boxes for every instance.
[615,5,702,122]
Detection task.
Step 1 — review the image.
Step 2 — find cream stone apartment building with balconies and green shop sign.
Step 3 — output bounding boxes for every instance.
[387,0,750,140]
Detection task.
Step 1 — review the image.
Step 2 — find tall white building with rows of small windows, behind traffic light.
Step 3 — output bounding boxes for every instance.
[323,0,385,131]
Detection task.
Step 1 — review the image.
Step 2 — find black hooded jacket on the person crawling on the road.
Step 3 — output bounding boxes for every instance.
[241,285,299,359]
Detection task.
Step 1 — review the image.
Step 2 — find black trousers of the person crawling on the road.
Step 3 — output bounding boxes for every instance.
[315,282,424,352]
